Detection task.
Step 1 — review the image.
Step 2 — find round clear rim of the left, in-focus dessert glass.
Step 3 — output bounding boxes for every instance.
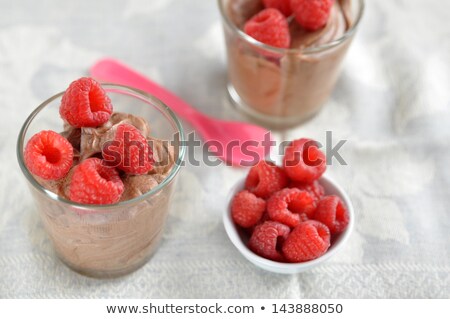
[16,83,186,213]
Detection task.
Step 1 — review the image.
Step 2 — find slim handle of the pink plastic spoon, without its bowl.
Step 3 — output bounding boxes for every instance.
[90,58,203,127]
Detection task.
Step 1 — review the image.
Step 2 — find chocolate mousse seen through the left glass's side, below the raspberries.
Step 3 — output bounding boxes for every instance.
[34,178,173,277]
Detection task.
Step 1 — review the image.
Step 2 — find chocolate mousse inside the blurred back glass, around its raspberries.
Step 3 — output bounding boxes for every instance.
[225,0,353,120]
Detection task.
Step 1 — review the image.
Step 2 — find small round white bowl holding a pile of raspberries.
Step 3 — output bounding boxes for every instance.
[223,176,355,274]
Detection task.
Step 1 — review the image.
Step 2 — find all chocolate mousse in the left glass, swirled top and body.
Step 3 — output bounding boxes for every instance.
[31,113,175,275]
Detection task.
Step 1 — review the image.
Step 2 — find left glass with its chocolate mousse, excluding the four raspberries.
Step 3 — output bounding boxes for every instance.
[17,84,185,277]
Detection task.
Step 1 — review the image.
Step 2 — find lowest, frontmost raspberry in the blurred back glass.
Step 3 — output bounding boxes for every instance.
[244,8,291,49]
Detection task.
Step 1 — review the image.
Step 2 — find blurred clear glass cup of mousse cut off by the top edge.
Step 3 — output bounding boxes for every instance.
[218,0,364,128]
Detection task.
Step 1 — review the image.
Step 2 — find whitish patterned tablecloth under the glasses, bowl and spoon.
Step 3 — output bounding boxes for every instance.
[0,0,450,298]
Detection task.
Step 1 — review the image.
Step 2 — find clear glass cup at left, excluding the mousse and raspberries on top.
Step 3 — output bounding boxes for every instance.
[17,84,185,278]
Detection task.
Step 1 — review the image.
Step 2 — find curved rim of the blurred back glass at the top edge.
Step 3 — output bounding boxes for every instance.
[217,0,365,55]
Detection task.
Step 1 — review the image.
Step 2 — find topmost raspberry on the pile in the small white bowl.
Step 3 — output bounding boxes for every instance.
[245,161,288,198]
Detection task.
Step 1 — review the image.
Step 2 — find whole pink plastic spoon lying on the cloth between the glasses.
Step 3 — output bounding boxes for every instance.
[90,58,271,166]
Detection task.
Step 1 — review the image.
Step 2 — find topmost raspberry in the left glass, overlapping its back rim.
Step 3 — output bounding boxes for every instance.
[59,78,113,128]
